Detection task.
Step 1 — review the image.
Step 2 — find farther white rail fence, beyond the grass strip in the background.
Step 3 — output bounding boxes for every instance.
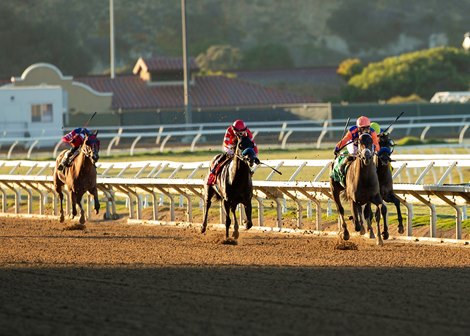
[0,115,470,159]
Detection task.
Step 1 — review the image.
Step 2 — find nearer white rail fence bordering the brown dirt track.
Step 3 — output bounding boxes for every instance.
[0,155,470,243]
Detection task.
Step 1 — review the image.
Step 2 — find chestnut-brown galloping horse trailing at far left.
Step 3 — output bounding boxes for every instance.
[54,134,100,224]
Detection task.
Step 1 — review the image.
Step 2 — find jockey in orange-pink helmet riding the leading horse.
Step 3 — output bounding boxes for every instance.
[334,116,380,174]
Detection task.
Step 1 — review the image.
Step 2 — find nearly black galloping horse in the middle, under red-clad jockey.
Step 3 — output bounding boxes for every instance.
[201,136,255,240]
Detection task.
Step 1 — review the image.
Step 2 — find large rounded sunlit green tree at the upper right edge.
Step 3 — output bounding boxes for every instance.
[342,47,470,102]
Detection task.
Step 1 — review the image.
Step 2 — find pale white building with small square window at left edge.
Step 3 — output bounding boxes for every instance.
[0,85,67,145]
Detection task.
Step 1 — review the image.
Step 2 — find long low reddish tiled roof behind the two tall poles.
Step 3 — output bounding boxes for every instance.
[74,75,316,110]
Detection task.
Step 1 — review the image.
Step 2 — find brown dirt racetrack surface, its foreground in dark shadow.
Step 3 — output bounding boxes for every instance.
[0,218,470,336]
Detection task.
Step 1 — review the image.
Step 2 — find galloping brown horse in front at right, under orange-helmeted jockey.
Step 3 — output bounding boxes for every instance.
[330,133,388,245]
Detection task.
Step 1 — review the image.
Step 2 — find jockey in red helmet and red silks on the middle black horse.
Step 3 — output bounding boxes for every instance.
[207,119,260,185]
